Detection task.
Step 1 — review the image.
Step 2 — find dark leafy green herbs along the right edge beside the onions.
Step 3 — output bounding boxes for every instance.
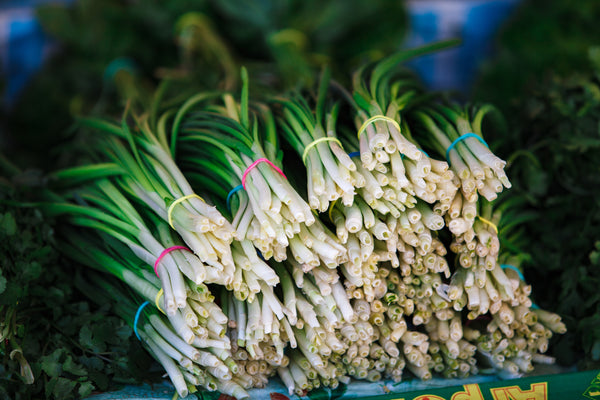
[482,54,600,369]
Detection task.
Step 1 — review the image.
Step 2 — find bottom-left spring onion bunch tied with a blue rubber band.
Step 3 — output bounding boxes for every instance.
[52,223,248,398]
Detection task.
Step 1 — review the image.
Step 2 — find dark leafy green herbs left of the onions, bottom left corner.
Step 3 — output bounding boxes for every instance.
[0,170,159,400]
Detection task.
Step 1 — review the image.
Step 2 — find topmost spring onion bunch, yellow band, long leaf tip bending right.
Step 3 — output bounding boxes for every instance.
[347,43,456,211]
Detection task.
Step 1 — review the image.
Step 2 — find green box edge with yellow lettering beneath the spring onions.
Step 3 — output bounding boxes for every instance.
[87,370,600,400]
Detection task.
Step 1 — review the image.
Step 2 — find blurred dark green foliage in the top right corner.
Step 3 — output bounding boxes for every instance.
[473,0,600,111]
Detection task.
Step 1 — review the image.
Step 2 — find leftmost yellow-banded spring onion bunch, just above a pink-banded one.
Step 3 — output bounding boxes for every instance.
[76,113,240,283]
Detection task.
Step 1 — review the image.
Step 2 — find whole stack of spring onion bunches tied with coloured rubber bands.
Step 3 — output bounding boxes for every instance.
[42,47,565,399]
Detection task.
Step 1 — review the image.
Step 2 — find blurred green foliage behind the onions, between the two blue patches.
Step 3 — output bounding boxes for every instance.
[6,0,406,169]
